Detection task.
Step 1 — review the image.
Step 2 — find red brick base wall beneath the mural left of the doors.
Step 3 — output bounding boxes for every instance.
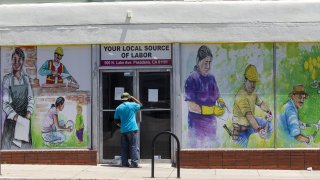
[0,150,97,165]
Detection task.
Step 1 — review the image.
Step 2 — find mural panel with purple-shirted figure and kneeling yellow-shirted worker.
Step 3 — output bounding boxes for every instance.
[181,43,274,148]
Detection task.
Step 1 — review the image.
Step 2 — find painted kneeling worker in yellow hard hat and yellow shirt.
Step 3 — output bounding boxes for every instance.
[232,64,273,147]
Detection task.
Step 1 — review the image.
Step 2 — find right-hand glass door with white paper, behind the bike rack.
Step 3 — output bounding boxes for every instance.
[138,71,171,159]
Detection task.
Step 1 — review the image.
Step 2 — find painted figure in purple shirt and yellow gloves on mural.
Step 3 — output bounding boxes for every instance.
[185,45,224,148]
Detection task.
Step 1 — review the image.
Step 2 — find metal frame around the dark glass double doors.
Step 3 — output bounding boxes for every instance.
[98,67,174,164]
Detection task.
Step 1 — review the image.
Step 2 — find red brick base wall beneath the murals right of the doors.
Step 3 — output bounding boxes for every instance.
[180,149,320,170]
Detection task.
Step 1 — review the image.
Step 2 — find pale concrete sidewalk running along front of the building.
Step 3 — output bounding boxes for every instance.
[0,163,320,180]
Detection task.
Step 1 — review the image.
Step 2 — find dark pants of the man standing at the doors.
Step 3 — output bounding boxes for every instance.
[121,131,139,166]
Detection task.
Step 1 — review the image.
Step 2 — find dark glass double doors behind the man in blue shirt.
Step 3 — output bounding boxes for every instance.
[100,69,171,163]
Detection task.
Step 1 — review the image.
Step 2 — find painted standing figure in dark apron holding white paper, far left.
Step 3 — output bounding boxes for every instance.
[1,47,35,150]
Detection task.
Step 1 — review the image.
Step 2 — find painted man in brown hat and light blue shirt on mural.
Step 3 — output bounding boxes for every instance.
[279,84,314,147]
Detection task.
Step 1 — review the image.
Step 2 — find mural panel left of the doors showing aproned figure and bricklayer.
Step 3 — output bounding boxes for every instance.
[1,46,91,150]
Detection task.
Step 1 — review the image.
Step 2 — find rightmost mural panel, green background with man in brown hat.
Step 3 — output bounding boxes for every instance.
[276,43,320,148]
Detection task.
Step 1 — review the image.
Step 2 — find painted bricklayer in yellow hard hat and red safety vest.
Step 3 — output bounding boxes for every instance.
[39,47,77,84]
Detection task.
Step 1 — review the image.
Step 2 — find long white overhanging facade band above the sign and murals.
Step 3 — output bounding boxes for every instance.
[0,1,320,45]
